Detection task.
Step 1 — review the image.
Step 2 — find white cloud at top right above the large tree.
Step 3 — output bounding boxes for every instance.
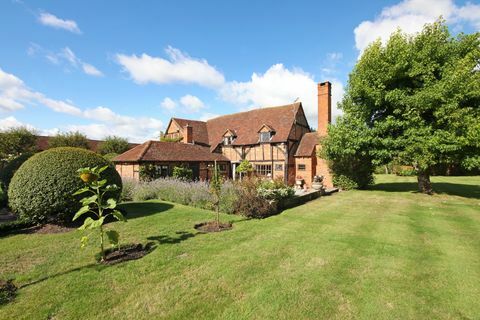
[354,0,480,53]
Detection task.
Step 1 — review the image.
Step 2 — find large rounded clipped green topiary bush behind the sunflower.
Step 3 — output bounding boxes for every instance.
[8,147,122,223]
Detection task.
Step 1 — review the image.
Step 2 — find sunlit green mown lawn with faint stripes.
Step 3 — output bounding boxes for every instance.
[0,176,480,319]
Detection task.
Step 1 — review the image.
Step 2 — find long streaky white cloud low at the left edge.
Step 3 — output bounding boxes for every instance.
[0,69,163,142]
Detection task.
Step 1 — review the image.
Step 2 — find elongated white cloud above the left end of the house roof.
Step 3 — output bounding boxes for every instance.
[116,46,225,88]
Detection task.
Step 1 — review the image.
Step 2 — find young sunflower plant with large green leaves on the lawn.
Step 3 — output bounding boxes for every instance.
[72,165,127,261]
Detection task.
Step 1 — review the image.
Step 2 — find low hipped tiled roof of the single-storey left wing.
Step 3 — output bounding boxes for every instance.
[113,140,229,162]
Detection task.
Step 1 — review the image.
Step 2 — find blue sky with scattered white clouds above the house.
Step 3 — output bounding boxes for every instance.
[0,0,480,142]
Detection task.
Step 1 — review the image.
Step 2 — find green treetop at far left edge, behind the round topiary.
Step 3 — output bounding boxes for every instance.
[0,127,37,160]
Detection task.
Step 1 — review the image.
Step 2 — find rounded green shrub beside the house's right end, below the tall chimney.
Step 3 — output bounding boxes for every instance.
[319,115,374,190]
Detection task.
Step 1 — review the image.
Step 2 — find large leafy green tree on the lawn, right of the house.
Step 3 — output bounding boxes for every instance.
[330,20,480,193]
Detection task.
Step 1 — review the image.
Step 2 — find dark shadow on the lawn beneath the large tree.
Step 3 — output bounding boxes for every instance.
[368,182,480,199]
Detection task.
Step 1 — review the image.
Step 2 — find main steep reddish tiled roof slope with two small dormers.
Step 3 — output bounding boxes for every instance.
[207,102,302,150]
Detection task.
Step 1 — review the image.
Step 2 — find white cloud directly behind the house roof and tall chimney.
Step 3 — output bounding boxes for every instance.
[220,64,343,127]
